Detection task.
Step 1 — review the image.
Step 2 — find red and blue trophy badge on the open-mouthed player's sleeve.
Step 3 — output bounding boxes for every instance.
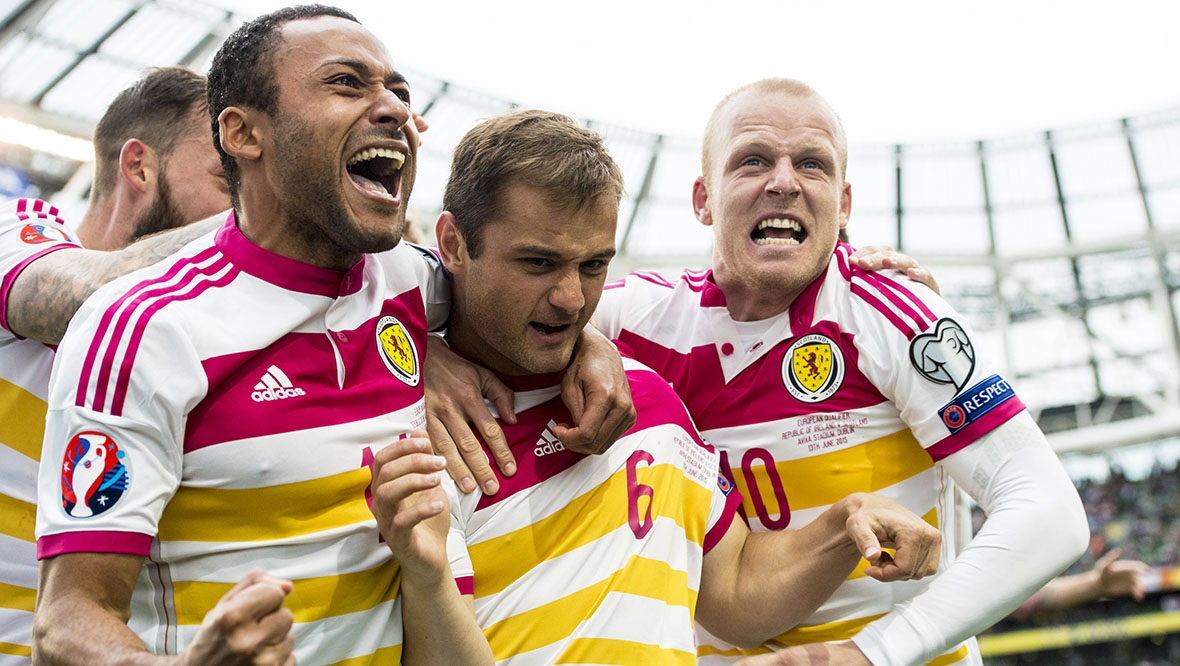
[61,432,131,518]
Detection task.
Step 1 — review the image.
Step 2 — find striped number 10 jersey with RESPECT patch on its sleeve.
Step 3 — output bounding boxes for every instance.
[596,243,1024,666]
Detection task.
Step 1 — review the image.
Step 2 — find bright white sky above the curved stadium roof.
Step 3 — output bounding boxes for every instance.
[219,0,1180,143]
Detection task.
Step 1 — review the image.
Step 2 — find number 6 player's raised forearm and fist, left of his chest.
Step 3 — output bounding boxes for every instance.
[372,430,493,666]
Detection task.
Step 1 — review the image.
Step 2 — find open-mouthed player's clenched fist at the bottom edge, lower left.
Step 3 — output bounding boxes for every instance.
[181,569,295,666]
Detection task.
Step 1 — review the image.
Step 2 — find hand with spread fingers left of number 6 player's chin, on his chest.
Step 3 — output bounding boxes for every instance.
[422,335,516,495]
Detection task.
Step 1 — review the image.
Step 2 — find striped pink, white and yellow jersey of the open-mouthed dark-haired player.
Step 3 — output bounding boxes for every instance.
[37,214,448,666]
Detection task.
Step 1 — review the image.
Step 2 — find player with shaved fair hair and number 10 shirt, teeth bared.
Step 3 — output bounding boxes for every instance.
[597,79,1088,666]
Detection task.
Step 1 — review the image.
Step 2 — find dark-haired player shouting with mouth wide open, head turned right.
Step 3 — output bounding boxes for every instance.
[33,6,491,666]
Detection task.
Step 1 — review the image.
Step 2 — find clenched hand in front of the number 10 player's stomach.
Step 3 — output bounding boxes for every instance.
[841,492,943,582]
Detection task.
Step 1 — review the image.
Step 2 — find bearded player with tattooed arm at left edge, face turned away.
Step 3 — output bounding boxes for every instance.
[0,67,229,666]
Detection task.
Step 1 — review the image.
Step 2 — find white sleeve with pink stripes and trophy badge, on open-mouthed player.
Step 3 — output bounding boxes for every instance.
[35,286,204,559]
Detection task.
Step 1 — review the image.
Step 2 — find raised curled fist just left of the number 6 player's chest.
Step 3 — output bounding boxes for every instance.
[372,430,451,576]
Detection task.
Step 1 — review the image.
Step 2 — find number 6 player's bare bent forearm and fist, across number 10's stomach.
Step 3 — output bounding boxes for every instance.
[696,492,942,647]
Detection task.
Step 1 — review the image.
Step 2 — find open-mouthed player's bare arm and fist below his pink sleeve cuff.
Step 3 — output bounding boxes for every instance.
[33,553,295,666]
